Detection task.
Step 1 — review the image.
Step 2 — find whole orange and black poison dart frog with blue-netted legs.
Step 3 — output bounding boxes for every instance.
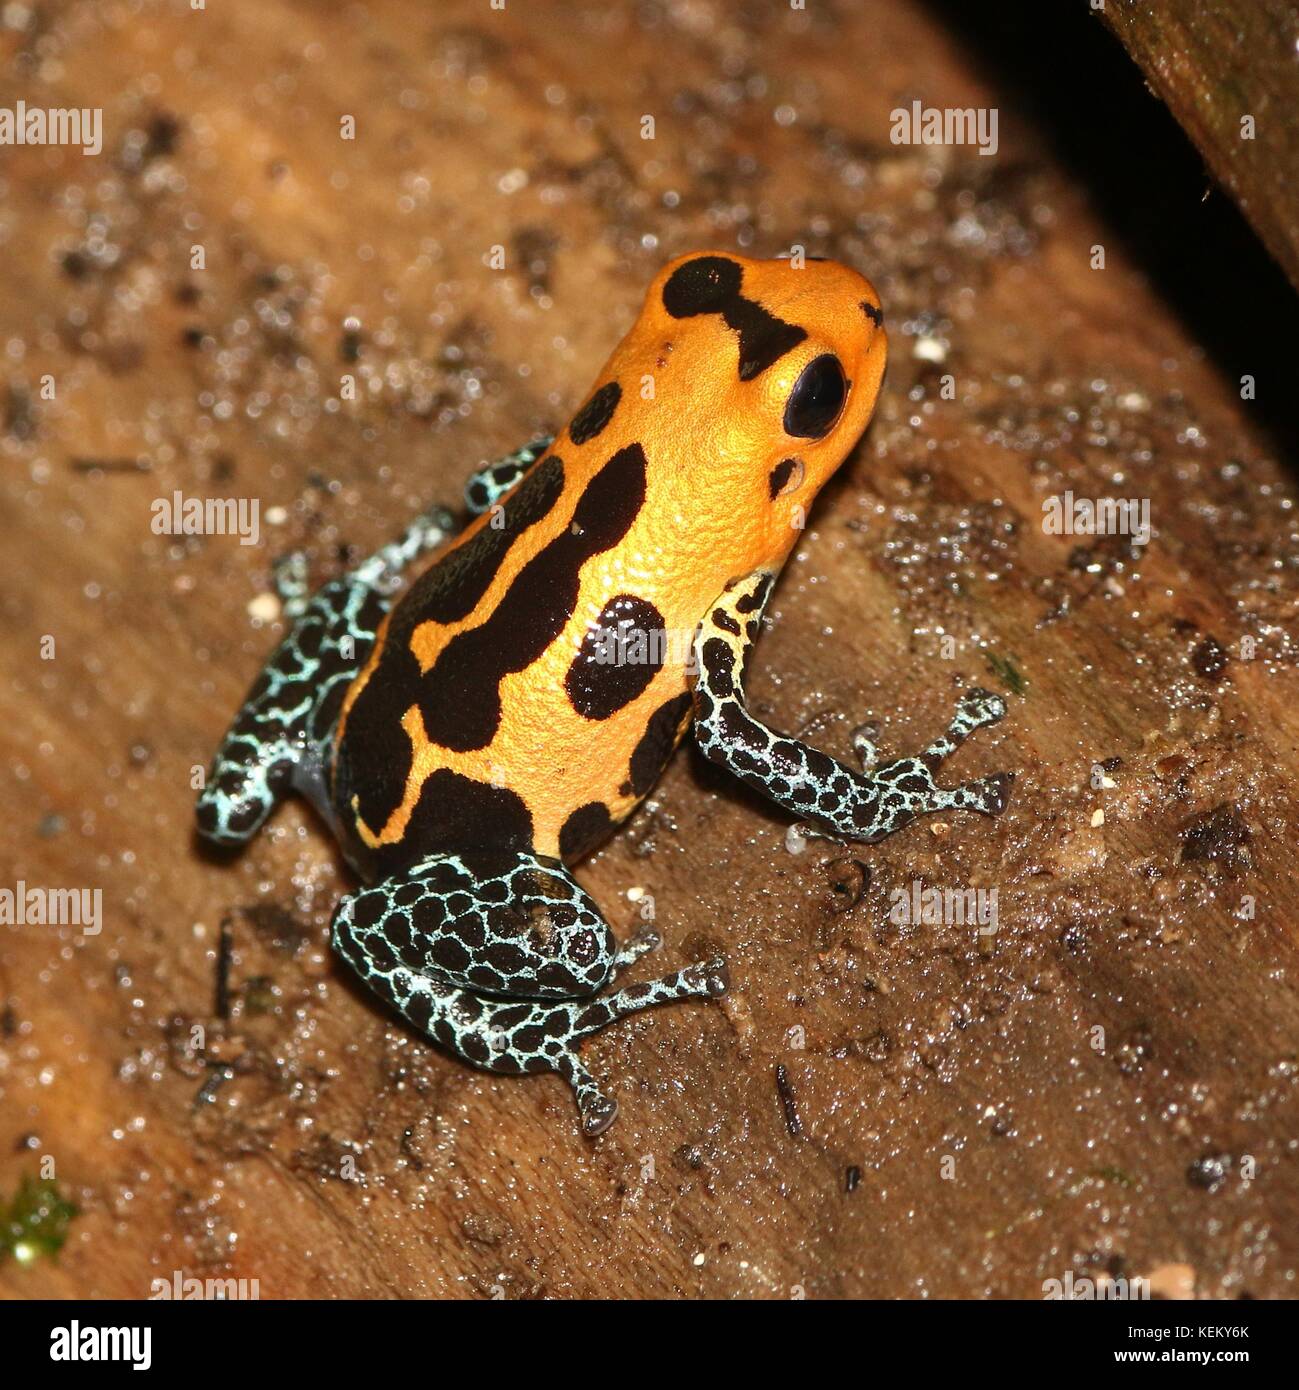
[197,254,1010,1134]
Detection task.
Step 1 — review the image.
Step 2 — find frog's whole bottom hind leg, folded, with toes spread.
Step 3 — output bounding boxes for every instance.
[333,852,727,1134]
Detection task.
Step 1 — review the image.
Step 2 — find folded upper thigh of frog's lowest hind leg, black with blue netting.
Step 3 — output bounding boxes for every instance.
[333,851,617,999]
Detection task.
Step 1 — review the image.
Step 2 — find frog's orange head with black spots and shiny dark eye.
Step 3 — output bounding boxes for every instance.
[589,253,886,578]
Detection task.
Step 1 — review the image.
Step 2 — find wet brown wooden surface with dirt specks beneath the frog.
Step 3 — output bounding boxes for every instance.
[0,0,1299,1298]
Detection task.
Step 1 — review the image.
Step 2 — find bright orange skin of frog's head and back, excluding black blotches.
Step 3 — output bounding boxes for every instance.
[335,253,886,859]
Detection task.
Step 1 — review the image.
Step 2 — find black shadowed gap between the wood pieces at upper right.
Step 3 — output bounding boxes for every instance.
[914,0,1299,468]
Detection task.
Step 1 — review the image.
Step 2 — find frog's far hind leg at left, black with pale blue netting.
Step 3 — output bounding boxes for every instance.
[196,507,454,845]
